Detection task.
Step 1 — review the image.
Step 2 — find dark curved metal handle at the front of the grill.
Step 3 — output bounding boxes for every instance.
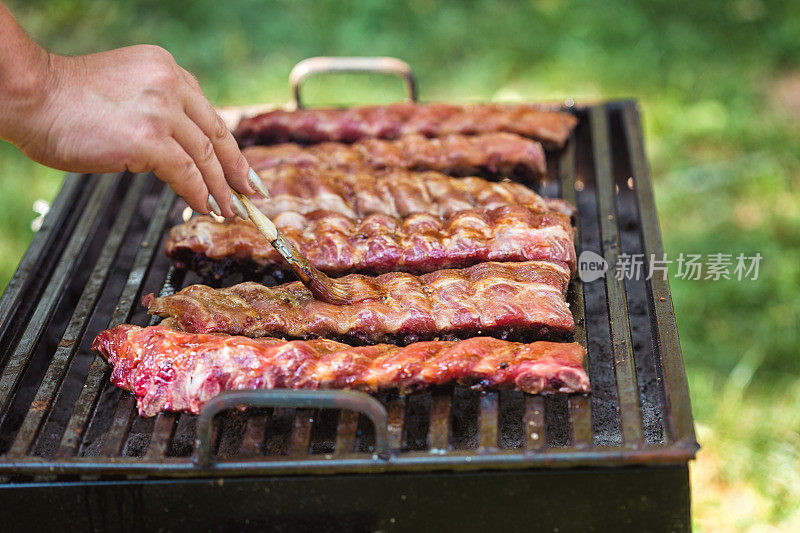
[194,389,392,467]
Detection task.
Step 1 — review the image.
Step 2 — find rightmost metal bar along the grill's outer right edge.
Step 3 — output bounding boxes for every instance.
[622,102,696,445]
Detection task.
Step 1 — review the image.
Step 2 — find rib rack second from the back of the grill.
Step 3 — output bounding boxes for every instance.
[244,133,546,176]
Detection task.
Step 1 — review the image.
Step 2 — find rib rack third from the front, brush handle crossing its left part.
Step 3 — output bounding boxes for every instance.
[165,205,576,279]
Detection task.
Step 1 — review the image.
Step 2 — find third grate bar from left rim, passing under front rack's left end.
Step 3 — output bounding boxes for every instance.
[57,187,175,457]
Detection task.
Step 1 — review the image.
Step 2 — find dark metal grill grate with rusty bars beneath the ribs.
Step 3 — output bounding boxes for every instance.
[0,102,697,480]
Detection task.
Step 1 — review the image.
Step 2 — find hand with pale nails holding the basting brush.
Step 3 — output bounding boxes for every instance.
[9,45,266,217]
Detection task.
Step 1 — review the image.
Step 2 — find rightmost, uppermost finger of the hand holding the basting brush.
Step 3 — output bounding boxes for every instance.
[181,69,255,196]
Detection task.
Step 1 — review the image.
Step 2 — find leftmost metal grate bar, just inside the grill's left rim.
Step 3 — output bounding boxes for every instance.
[0,177,117,425]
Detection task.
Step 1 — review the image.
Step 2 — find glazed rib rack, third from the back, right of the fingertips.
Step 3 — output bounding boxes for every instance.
[245,167,575,219]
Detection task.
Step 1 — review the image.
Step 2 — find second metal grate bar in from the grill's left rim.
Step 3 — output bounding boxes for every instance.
[9,177,147,456]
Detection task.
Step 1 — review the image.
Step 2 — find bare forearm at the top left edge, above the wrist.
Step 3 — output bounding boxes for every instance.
[0,2,50,146]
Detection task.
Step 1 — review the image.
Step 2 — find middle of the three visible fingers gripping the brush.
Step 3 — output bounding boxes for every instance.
[172,117,234,217]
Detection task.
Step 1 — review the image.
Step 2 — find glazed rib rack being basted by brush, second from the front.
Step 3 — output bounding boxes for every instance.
[143,261,574,344]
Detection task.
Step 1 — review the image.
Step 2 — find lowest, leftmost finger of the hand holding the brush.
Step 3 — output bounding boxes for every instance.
[152,138,209,214]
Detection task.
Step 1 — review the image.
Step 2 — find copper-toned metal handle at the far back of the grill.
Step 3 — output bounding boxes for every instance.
[289,56,417,109]
